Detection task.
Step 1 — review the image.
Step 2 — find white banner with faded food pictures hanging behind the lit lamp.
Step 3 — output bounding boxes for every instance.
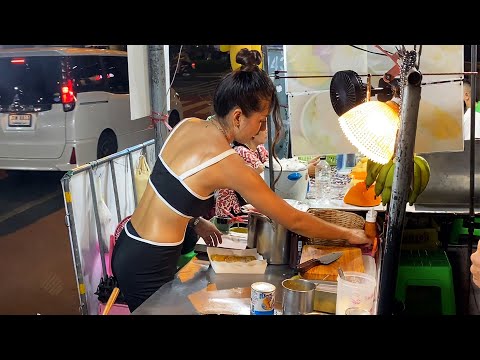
[284,45,463,155]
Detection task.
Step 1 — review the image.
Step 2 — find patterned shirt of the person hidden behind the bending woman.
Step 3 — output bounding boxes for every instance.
[215,144,268,216]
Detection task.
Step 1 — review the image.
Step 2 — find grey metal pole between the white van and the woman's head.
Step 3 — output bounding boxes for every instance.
[148,45,168,155]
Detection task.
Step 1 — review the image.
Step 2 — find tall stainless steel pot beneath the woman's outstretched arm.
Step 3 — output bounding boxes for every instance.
[247,212,290,265]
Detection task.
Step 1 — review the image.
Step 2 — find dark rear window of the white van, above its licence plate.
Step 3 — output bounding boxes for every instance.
[0,56,61,112]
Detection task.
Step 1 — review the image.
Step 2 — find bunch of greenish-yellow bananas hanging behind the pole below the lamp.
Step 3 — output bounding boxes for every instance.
[365,155,430,205]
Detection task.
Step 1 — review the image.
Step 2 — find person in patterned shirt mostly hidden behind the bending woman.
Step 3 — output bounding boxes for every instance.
[215,129,268,216]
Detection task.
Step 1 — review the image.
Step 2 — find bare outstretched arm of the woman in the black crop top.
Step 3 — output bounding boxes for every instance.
[225,158,372,244]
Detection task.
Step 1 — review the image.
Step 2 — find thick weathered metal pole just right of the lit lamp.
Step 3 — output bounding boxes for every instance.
[378,68,422,315]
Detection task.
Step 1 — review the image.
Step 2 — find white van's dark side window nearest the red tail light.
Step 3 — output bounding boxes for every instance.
[69,56,105,93]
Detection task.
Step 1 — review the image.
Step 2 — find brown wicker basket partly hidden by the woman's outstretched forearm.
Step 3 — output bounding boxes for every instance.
[307,209,365,246]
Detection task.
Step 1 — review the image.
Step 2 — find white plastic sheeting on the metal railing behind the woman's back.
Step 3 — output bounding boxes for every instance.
[64,143,156,315]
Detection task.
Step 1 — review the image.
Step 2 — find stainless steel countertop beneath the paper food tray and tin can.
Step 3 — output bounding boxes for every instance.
[132,259,295,315]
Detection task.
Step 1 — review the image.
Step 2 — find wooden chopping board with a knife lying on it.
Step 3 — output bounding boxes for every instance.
[300,245,365,282]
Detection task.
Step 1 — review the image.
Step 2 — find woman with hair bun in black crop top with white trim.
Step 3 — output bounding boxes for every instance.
[112,49,370,311]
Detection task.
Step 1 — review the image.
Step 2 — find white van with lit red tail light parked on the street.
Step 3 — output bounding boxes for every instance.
[0,47,183,171]
